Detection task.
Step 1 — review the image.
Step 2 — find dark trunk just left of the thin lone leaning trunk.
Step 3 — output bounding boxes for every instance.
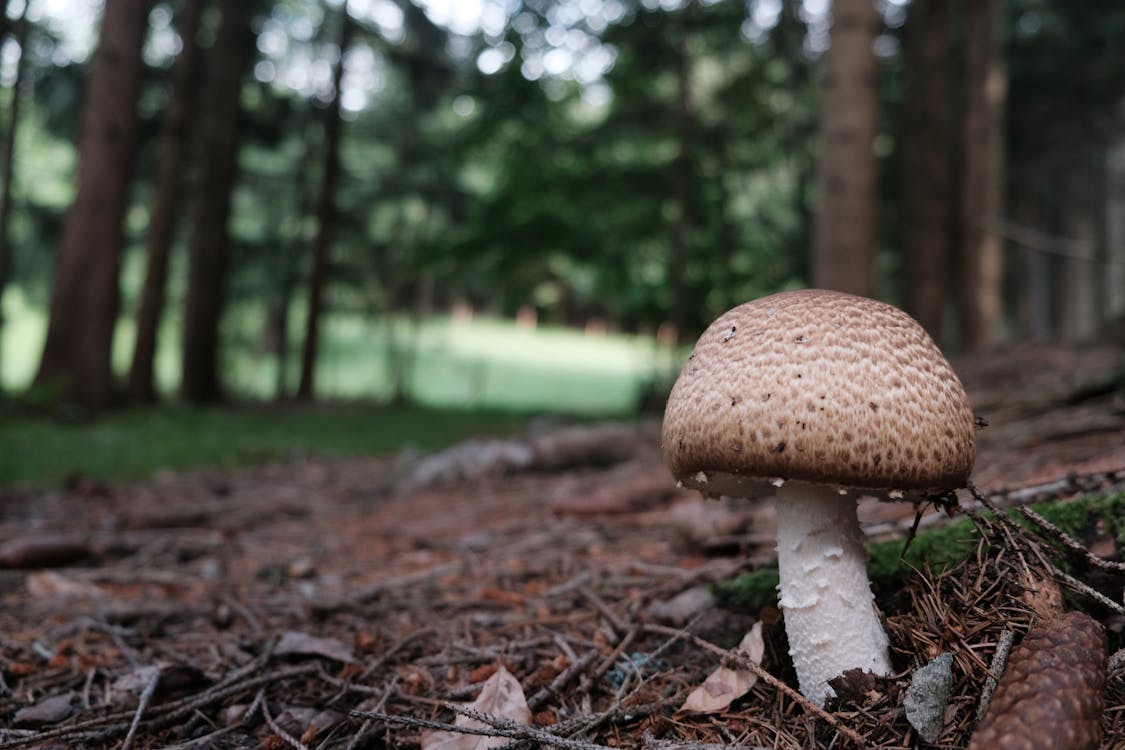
[180,0,254,403]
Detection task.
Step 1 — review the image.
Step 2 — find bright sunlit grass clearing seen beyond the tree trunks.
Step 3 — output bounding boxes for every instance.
[0,287,681,415]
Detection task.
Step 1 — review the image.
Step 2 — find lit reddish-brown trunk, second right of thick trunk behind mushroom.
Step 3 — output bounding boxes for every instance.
[961,0,1007,352]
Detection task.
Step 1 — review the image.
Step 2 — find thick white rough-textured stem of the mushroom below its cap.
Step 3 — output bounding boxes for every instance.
[776,481,891,705]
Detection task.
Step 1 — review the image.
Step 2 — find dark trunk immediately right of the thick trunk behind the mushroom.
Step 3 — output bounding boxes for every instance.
[901,0,952,343]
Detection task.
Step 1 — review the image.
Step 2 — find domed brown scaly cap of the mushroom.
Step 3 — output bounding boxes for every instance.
[662,289,975,495]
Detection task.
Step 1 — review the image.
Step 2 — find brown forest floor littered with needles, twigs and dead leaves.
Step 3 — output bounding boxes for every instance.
[0,349,1125,750]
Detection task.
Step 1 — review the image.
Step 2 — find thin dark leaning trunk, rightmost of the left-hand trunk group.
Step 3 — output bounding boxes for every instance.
[297,8,353,399]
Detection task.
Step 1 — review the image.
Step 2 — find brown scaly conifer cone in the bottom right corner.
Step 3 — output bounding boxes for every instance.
[969,612,1106,750]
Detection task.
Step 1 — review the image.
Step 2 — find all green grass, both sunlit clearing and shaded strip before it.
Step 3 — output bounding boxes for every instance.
[0,287,678,487]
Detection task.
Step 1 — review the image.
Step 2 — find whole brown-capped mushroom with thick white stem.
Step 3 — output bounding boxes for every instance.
[662,289,975,705]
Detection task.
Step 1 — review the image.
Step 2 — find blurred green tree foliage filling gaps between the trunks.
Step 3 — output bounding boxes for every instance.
[8,0,1125,404]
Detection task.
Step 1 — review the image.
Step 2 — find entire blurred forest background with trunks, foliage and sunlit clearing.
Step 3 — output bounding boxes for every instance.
[0,0,1125,463]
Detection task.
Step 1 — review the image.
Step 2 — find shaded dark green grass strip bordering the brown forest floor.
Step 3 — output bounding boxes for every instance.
[0,404,528,487]
